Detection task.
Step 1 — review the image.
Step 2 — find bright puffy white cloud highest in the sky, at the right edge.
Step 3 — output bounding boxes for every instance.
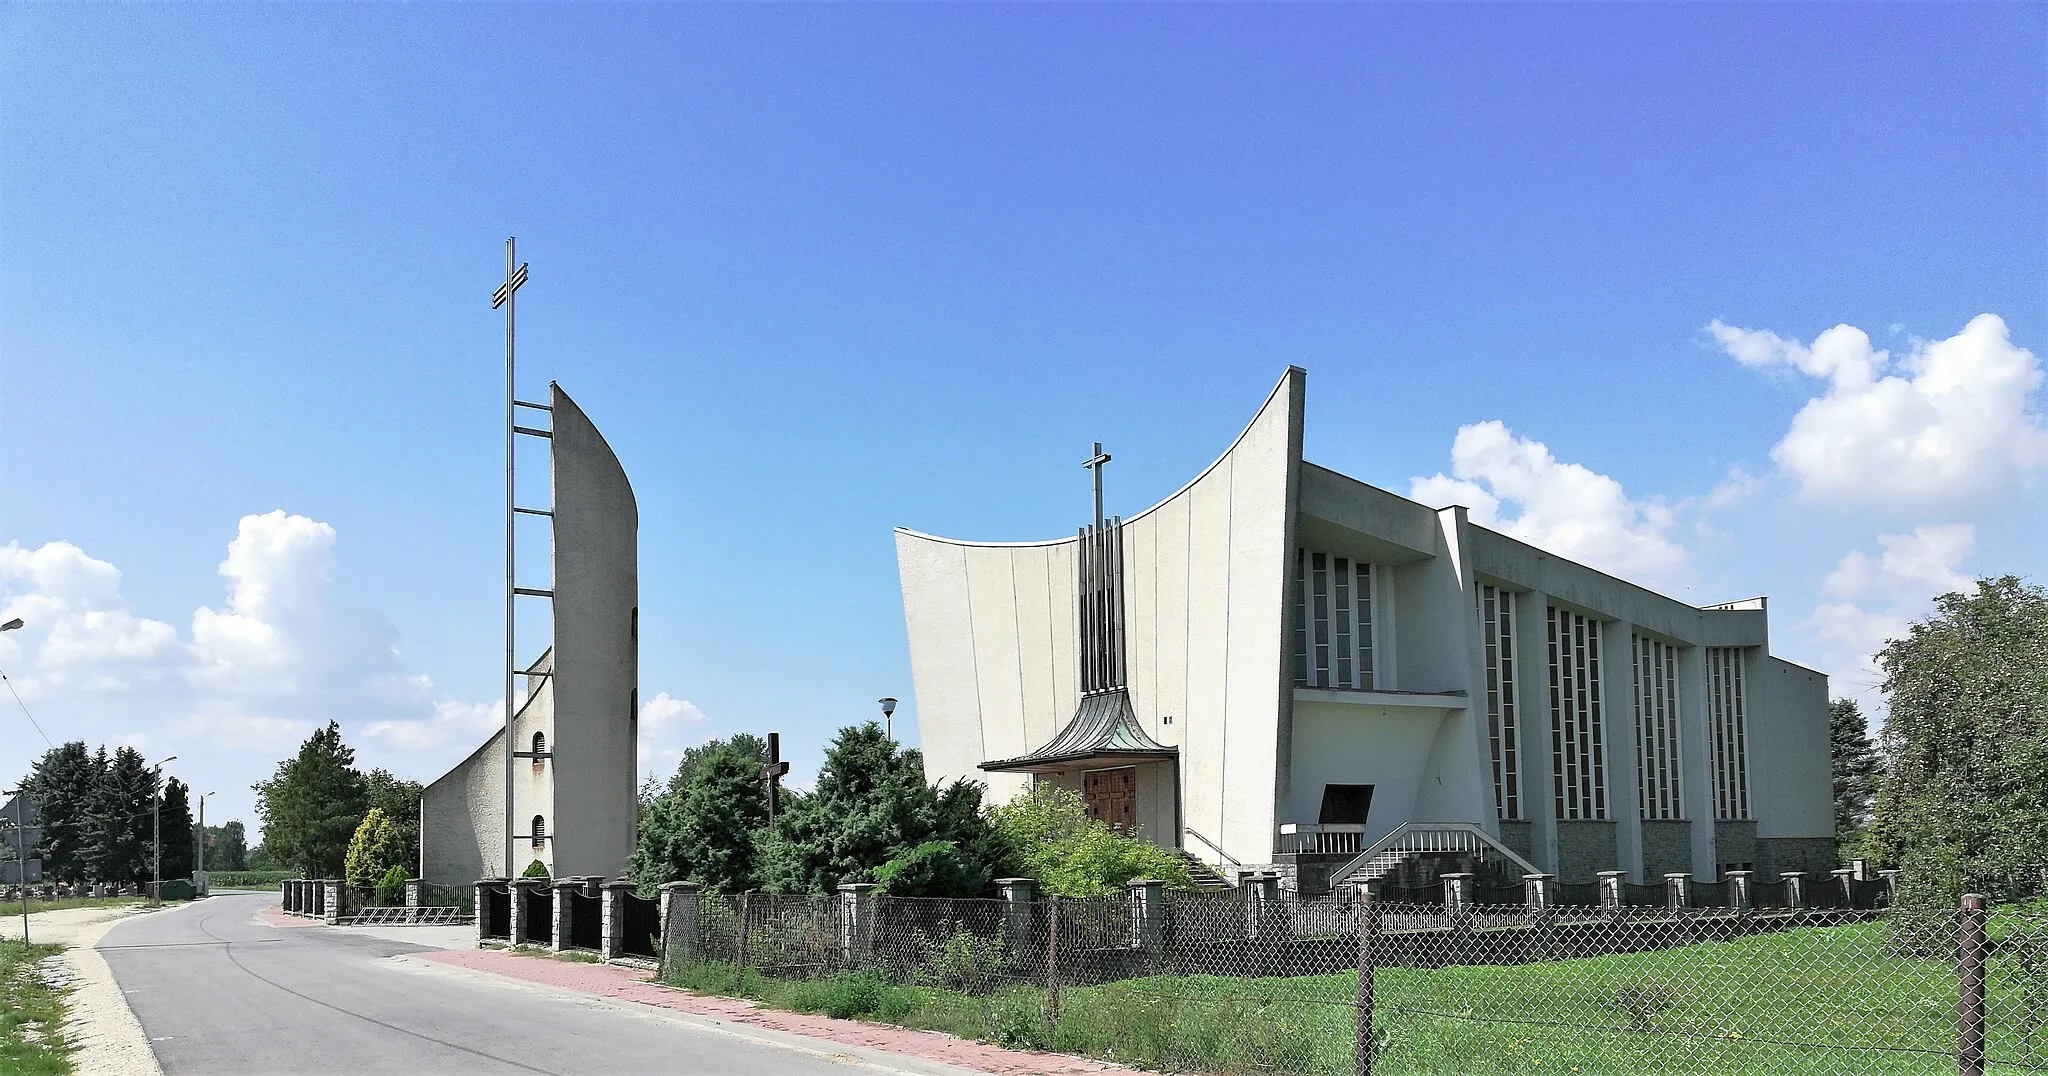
[1706,314,2048,504]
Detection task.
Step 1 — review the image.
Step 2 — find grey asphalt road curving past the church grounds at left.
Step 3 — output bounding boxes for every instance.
[98,894,909,1076]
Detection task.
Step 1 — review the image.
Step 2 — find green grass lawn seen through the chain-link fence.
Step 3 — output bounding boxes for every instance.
[670,922,2048,1076]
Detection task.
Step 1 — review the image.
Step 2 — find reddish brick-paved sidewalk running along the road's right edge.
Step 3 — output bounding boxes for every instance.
[414,949,1137,1076]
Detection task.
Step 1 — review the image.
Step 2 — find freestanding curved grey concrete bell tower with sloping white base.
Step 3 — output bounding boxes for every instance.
[420,383,639,885]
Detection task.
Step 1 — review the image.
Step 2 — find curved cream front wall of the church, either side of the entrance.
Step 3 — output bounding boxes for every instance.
[897,369,1305,863]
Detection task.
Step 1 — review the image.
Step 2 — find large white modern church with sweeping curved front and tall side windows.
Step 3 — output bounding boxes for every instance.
[897,369,1835,887]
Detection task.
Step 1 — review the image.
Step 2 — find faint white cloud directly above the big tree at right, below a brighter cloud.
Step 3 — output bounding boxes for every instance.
[1804,523,1976,713]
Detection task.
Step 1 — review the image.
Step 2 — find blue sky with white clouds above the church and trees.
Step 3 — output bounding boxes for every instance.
[0,4,2048,836]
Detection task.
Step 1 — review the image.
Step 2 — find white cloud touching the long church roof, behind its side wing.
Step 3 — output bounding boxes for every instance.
[1409,422,1695,584]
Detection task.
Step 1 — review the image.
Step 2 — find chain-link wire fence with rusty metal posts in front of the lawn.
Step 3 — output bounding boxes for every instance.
[662,883,2048,1074]
